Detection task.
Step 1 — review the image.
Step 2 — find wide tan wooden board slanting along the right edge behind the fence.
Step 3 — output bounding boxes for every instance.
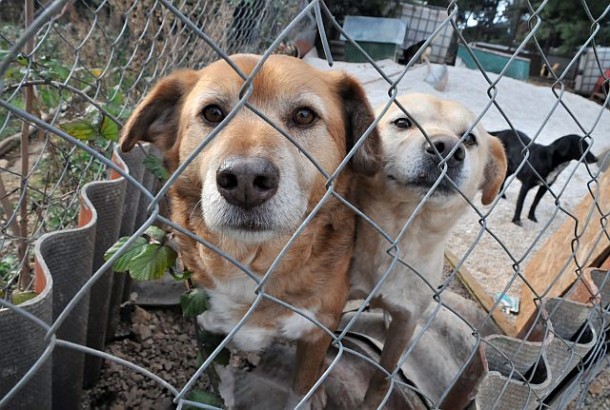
[515,172,610,334]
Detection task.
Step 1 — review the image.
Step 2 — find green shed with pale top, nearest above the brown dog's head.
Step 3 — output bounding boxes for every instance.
[341,16,407,63]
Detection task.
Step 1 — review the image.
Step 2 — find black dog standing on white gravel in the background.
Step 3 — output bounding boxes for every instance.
[490,129,597,226]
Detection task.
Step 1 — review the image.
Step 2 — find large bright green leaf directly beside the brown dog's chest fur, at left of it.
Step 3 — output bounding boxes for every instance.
[128,243,178,280]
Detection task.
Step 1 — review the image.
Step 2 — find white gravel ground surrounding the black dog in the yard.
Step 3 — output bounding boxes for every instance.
[307,54,610,306]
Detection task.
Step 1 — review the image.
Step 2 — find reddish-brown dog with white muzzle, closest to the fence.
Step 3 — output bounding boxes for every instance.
[121,55,382,408]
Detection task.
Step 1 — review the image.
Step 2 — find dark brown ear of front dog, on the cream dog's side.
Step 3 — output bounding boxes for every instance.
[339,75,383,175]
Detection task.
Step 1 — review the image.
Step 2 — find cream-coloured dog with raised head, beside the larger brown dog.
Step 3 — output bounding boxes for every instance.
[351,94,506,408]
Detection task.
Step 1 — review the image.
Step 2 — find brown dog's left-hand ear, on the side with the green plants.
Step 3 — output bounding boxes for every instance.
[119,70,198,153]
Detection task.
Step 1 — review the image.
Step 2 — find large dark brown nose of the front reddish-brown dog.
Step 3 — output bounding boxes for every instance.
[216,158,280,209]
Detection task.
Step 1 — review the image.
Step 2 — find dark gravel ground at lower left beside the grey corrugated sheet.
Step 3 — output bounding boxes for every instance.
[81,305,208,410]
